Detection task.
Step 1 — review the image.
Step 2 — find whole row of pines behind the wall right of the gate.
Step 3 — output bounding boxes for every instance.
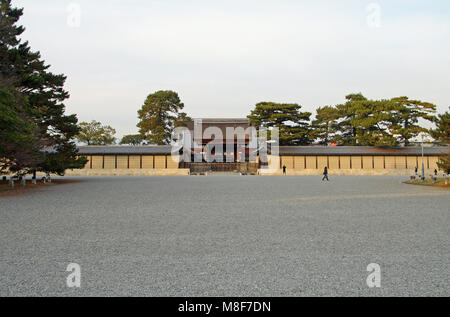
[248,93,437,146]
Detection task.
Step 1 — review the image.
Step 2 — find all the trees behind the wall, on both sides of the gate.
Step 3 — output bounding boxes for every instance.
[79,91,449,170]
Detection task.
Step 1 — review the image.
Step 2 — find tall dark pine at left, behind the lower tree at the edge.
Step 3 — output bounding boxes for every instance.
[0,0,86,174]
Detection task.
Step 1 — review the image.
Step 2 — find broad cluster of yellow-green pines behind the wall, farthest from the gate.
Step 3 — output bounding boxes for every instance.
[313,93,436,146]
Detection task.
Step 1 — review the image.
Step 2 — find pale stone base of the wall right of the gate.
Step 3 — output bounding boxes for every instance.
[258,169,442,177]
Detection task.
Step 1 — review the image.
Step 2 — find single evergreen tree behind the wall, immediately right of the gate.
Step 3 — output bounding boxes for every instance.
[248,102,312,146]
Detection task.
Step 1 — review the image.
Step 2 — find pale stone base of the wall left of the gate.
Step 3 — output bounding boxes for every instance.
[66,169,189,176]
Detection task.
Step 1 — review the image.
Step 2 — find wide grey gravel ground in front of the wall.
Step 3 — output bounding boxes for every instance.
[0,176,450,296]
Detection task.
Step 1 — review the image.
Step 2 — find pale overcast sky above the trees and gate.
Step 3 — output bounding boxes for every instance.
[12,0,450,136]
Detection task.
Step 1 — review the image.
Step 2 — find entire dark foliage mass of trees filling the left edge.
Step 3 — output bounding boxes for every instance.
[0,0,86,174]
